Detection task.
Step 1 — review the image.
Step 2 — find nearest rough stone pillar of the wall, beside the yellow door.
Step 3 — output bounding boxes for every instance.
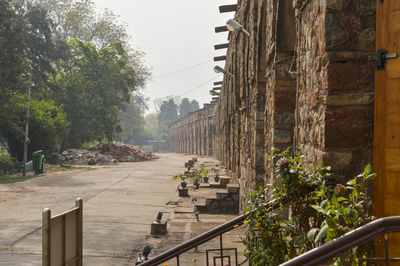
[296,0,376,180]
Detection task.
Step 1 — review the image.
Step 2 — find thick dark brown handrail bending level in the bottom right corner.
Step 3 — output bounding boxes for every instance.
[281,216,400,266]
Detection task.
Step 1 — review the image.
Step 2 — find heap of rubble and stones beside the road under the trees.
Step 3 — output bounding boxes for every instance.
[60,143,157,165]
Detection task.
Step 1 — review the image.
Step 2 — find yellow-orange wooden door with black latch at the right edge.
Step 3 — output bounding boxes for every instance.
[373,0,400,256]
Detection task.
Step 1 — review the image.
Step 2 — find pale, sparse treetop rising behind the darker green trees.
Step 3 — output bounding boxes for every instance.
[37,0,151,88]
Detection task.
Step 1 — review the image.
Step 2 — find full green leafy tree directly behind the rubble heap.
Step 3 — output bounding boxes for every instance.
[57,39,135,147]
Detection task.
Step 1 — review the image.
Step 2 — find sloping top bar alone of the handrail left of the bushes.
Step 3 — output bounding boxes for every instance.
[140,213,248,266]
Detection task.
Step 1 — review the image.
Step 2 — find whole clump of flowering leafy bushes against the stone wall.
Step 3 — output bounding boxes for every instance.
[243,149,374,265]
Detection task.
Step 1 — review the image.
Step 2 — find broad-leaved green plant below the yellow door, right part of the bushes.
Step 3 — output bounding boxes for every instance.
[308,165,375,265]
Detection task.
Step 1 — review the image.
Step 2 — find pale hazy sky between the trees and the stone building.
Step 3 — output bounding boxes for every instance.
[94,0,237,111]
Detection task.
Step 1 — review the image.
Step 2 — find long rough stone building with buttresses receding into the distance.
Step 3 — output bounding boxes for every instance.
[171,0,376,197]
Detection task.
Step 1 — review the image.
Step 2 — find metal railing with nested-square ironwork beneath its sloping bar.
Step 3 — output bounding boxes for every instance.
[140,215,247,266]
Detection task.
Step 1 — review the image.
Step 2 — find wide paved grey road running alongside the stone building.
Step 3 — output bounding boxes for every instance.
[0,154,190,265]
